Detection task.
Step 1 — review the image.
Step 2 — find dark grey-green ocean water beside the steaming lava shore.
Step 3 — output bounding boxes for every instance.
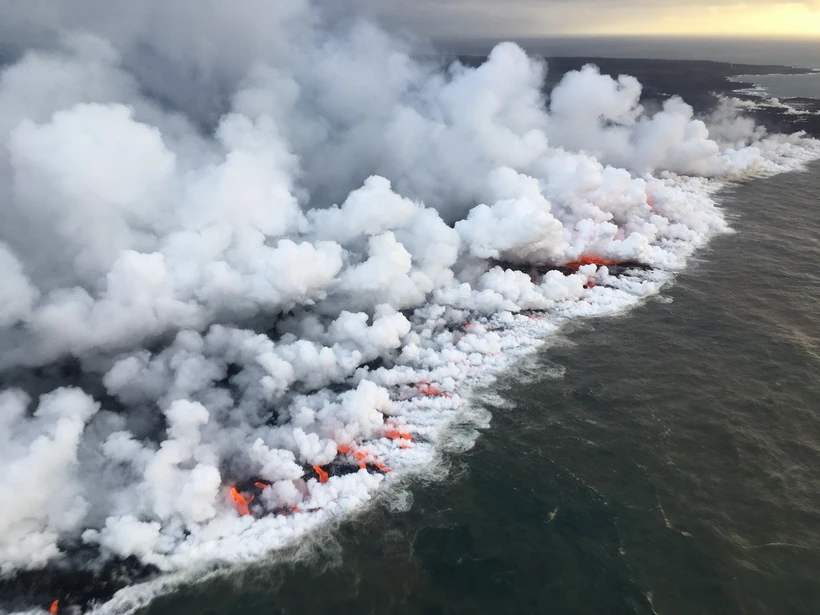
[133,165,820,615]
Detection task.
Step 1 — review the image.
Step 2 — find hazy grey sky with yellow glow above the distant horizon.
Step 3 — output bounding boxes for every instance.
[364,0,820,38]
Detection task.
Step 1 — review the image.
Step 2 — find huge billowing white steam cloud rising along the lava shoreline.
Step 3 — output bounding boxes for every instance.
[0,0,820,612]
